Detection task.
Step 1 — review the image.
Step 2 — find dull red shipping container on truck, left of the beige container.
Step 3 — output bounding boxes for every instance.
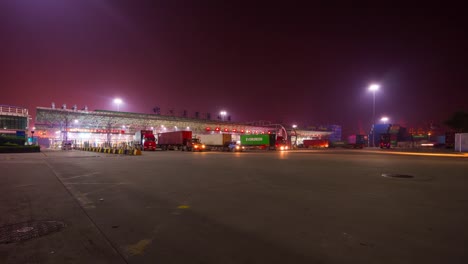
[158,131,193,151]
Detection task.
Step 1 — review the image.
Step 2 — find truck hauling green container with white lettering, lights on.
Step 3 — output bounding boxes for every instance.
[240,134,288,150]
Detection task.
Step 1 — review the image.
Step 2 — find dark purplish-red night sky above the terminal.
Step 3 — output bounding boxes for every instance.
[0,0,468,136]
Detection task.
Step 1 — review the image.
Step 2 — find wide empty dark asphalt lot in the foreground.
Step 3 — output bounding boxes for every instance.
[0,150,468,264]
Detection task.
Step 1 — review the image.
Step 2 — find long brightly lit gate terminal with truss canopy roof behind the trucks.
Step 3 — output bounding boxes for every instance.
[35,107,332,148]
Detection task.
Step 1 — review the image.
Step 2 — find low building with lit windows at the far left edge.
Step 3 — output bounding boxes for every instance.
[0,105,29,136]
